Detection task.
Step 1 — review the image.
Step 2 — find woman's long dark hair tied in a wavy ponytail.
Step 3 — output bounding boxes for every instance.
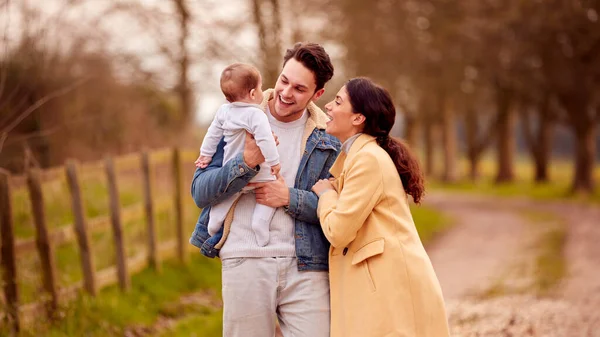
[346,77,425,204]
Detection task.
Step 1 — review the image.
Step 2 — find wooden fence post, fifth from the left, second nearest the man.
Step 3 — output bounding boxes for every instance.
[141,151,160,272]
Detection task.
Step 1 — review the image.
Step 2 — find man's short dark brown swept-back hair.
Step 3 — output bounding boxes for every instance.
[283,42,333,91]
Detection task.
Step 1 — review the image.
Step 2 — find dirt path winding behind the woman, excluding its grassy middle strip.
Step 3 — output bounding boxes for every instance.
[426,193,600,336]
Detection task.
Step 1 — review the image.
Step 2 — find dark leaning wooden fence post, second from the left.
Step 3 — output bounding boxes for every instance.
[27,168,58,319]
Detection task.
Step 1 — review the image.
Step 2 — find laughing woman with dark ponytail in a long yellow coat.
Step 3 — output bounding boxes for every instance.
[312,78,449,337]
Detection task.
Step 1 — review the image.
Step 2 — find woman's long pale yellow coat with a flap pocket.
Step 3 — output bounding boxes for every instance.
[318,134,449,337]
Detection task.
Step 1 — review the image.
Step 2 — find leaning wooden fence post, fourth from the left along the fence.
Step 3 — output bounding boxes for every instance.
[105,157,131,291]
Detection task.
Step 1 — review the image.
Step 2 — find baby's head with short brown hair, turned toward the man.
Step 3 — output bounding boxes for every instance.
[221,63,260,102]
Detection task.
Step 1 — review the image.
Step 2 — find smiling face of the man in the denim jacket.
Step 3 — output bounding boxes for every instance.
[271,58,325,123]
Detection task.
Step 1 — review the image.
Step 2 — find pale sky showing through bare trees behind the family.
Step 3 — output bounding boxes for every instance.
[0,0,343,125]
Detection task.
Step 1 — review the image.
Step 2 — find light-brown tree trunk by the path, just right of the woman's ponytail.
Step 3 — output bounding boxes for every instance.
[442,98,456,182]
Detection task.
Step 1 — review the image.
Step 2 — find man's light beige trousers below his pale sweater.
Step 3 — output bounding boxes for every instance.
[222,257,330,337]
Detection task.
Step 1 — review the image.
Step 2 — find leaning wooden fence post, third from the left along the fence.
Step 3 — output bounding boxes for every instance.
[66,160,97,296]
